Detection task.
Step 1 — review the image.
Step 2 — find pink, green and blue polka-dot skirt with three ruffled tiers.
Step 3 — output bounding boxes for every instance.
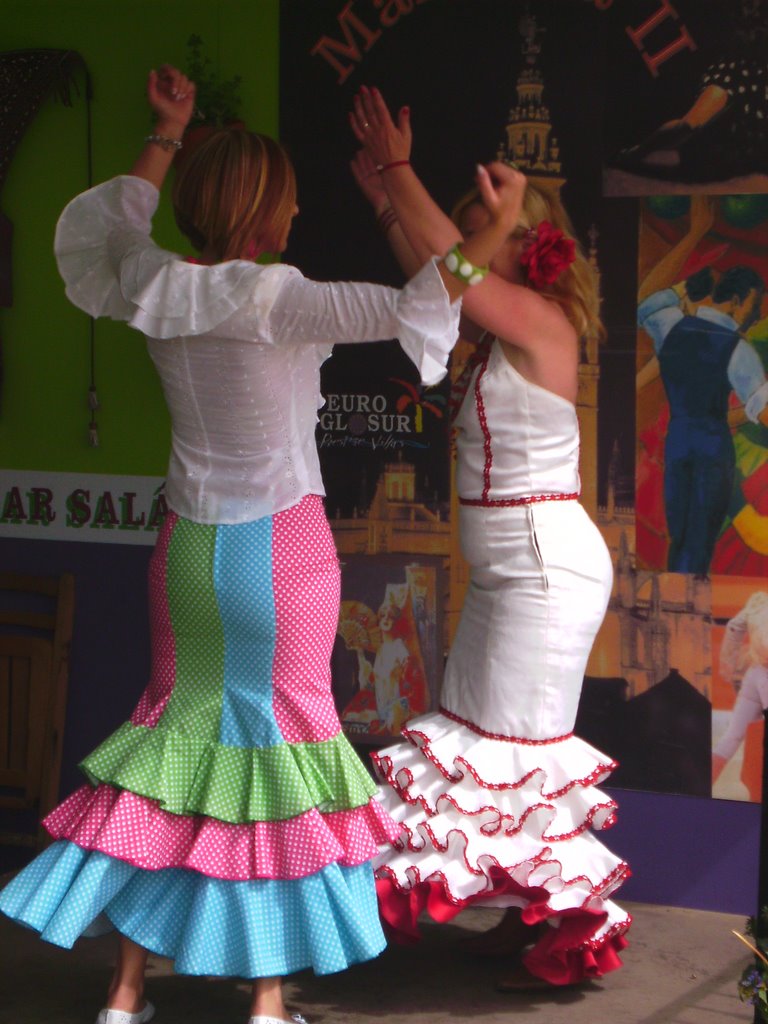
[0,496,397,978]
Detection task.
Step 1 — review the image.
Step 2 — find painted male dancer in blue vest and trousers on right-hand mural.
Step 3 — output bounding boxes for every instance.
[637,197,768,575]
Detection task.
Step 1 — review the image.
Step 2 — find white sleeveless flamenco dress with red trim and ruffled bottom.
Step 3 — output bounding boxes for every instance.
[374,342,631,984]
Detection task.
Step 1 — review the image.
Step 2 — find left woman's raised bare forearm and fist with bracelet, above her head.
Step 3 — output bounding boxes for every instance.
[130,65,195,188]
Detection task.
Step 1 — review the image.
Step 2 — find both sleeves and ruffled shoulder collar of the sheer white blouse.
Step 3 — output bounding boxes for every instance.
[54,175,461,384]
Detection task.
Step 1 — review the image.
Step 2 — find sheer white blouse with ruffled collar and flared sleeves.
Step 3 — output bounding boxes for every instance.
[54,176,460,523]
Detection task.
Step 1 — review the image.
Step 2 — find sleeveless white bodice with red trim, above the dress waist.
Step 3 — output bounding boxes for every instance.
[456,341,580,502]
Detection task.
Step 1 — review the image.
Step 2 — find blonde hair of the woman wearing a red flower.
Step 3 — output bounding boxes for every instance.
[451,181,605,339]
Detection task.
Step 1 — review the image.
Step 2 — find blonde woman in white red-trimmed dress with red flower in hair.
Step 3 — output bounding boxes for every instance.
[350,89,630,989]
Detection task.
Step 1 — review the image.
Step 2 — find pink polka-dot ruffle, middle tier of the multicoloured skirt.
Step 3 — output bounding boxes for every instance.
[44,785,398,882]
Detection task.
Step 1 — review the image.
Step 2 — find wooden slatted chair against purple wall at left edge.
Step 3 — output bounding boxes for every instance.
[0,572,75,848]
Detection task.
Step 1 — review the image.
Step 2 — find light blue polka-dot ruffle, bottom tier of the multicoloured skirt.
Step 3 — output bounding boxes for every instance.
[0,842,384,978]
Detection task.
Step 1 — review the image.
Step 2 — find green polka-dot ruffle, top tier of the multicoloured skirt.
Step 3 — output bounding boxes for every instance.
[80,722,376,823]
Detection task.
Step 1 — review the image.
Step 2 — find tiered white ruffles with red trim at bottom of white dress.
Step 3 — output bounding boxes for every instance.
[374,713,631,984]
